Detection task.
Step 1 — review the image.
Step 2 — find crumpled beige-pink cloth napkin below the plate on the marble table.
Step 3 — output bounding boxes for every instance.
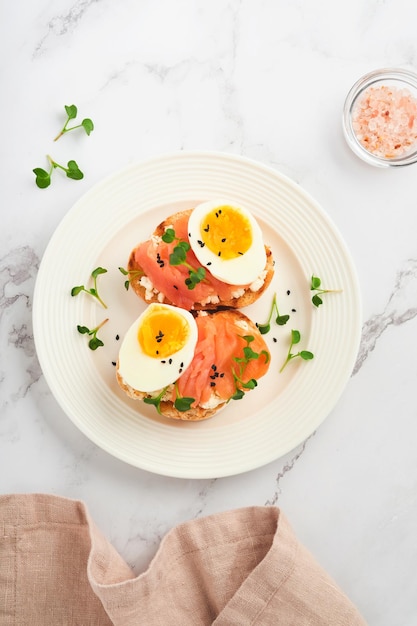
[0,494,366,626]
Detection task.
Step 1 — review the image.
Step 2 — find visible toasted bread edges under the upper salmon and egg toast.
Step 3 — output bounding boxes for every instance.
[127,209,274,311]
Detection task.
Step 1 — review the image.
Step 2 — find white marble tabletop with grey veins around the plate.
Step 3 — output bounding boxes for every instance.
[0,0,417,626]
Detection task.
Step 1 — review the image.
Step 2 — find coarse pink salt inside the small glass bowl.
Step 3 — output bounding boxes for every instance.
[352,85,417,159]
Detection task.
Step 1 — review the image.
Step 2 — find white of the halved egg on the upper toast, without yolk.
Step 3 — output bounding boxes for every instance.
[188,200,266,285]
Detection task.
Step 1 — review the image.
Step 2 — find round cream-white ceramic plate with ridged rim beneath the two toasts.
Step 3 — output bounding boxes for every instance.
[33,152,361,478]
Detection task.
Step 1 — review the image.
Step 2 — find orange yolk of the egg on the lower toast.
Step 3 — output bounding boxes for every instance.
[138,307,190,359]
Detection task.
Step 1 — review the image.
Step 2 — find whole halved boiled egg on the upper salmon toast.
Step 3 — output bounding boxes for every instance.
[188,201,266,285]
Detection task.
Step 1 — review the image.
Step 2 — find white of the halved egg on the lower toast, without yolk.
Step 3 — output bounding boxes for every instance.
[118,304,198,392]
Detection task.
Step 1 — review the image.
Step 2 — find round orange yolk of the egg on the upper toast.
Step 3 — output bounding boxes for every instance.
[201,206,252,260]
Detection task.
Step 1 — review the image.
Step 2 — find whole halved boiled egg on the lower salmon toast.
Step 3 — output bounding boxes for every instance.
[118,303,198,392]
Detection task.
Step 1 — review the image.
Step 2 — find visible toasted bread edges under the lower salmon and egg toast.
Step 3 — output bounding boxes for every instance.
[116,309,269,422]
